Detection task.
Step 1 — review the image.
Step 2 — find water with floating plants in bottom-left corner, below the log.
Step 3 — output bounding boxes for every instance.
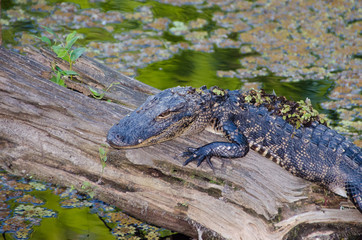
[0,169,175,240]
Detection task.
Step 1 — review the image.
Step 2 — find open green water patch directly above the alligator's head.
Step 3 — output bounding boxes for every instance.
[137,49,246,89]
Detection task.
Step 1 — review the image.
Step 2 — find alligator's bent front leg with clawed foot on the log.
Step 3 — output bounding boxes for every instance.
[182,121,249,169]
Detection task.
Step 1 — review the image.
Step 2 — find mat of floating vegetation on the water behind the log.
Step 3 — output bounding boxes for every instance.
[2,0,360,84]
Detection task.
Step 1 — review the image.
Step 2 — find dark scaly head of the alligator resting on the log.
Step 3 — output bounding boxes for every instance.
[107,87,211,148]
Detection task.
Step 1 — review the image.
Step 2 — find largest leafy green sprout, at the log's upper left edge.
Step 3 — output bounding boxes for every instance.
[35,26,85,86]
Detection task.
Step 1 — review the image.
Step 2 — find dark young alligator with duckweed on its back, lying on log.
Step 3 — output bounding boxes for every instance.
[107,86,362,213]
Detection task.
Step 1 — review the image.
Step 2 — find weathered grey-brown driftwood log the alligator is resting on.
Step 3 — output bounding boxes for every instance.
[0,48,362,239]
